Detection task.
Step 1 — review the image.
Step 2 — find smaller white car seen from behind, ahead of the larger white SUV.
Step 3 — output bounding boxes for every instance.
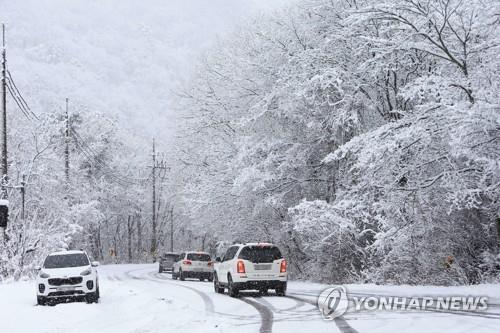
[172,251,214,281]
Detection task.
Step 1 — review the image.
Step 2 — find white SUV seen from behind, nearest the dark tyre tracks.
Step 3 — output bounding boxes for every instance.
[214,243,288,297]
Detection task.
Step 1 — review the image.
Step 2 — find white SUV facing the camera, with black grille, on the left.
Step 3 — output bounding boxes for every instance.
[36,251,99,305]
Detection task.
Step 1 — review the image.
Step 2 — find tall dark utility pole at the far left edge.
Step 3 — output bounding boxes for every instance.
[0,23,9,241]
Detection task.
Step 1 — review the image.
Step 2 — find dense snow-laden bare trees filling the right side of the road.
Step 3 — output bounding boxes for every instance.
[173,0,500,284]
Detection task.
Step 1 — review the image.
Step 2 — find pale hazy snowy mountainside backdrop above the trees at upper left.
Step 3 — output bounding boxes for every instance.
[0,0,290,139]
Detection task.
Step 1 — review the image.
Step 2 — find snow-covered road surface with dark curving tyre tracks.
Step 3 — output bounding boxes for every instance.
[0,265,500,333]
